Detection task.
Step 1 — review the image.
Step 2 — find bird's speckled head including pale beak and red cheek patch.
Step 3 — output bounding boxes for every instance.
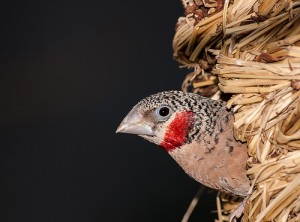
[116,91,222,151]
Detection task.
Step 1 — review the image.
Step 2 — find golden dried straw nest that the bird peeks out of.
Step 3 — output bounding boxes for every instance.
[173,0,300,222]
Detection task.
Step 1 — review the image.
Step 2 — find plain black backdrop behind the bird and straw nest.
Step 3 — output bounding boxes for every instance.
[0,0,215,222]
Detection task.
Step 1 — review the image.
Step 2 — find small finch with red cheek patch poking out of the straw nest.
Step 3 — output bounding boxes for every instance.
[116,90,250,197]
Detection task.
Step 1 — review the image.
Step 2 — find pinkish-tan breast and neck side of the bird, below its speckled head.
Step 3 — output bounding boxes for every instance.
[169,112,249,196]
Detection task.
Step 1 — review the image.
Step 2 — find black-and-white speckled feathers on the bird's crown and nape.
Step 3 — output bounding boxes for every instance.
[137,91,232,143]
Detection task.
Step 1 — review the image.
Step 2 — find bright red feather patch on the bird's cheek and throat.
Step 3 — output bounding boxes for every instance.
[160,112,193,152]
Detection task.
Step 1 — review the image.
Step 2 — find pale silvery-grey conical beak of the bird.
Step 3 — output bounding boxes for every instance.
[116,106,153,136]
